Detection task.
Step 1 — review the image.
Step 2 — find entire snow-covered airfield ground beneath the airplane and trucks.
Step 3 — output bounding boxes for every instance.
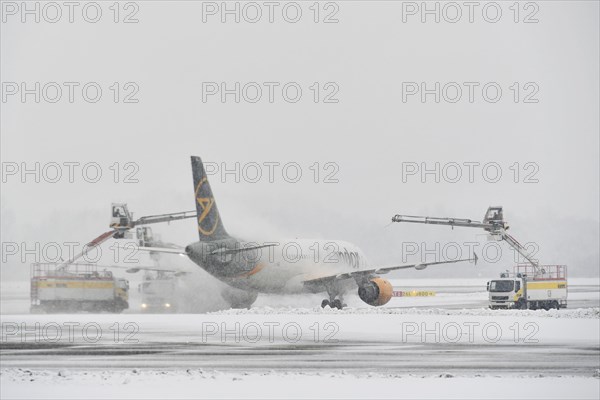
[0,281,600,399]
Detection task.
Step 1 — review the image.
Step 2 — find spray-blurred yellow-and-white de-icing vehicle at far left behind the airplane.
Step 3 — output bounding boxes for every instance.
[31,263,129,313]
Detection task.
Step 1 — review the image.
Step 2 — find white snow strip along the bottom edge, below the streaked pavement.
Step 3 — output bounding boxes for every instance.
[1,369,599,399]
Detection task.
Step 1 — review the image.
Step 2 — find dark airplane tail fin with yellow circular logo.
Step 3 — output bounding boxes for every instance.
[192,156,229,242]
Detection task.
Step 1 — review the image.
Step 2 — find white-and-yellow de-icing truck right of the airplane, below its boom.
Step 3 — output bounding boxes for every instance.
[487,264,567,310]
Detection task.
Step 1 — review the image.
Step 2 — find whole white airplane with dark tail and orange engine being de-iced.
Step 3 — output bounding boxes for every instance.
[140,156,477,309]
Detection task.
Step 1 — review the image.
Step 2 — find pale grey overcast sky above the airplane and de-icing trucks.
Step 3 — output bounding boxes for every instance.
[0,1,600,279]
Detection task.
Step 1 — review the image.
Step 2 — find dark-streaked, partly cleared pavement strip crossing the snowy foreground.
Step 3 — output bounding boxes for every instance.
[2,341,600,377]
